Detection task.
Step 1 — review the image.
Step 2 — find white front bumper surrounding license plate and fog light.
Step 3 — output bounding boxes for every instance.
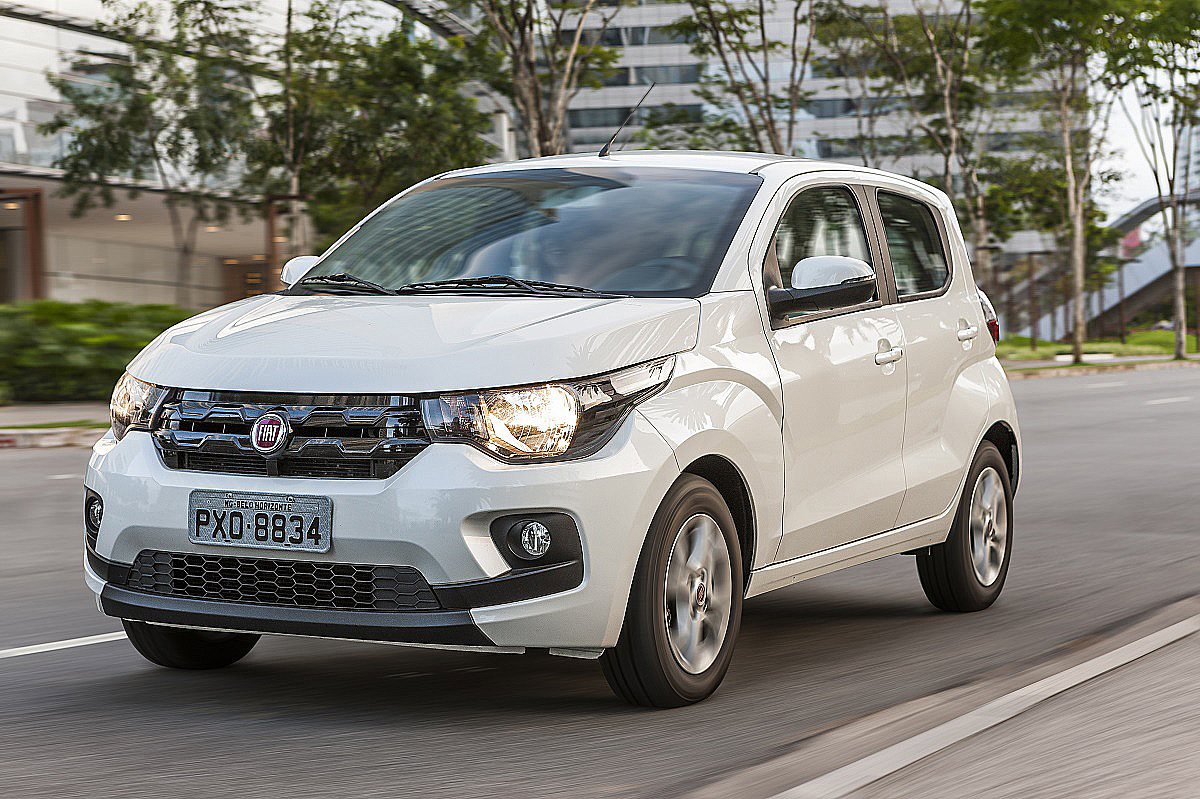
[85,413,678,649]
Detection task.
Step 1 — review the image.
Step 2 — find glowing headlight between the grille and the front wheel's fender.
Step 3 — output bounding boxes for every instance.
[421,355,674,462]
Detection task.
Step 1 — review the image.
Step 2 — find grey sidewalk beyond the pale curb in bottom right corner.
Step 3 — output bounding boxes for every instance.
[850,635,1200,799]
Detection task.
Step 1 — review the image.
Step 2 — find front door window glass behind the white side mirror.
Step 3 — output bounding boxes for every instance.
[763,186,871,288]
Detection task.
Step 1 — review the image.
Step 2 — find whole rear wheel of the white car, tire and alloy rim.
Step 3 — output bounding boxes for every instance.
[917,441,1013,613]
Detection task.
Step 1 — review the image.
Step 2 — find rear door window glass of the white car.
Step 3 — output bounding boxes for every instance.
[880,192,950,296]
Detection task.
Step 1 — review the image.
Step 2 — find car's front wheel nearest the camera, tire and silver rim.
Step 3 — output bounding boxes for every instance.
[601,475,744,708]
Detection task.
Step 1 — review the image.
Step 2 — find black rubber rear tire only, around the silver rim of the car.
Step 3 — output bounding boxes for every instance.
[917,441,1013,613]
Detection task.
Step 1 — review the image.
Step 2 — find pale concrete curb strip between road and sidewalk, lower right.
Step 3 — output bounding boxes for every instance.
[772,614,1200,799]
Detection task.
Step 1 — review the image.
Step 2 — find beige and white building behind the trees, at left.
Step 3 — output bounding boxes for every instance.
[0,0,512,308]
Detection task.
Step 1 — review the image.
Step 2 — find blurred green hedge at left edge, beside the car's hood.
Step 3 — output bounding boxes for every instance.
[0,300,193,402]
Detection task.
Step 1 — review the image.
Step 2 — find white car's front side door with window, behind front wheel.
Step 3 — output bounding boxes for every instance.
[763,185,907,560]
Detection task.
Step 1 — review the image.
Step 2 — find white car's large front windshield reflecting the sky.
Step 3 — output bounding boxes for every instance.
[305,168,762,296]
